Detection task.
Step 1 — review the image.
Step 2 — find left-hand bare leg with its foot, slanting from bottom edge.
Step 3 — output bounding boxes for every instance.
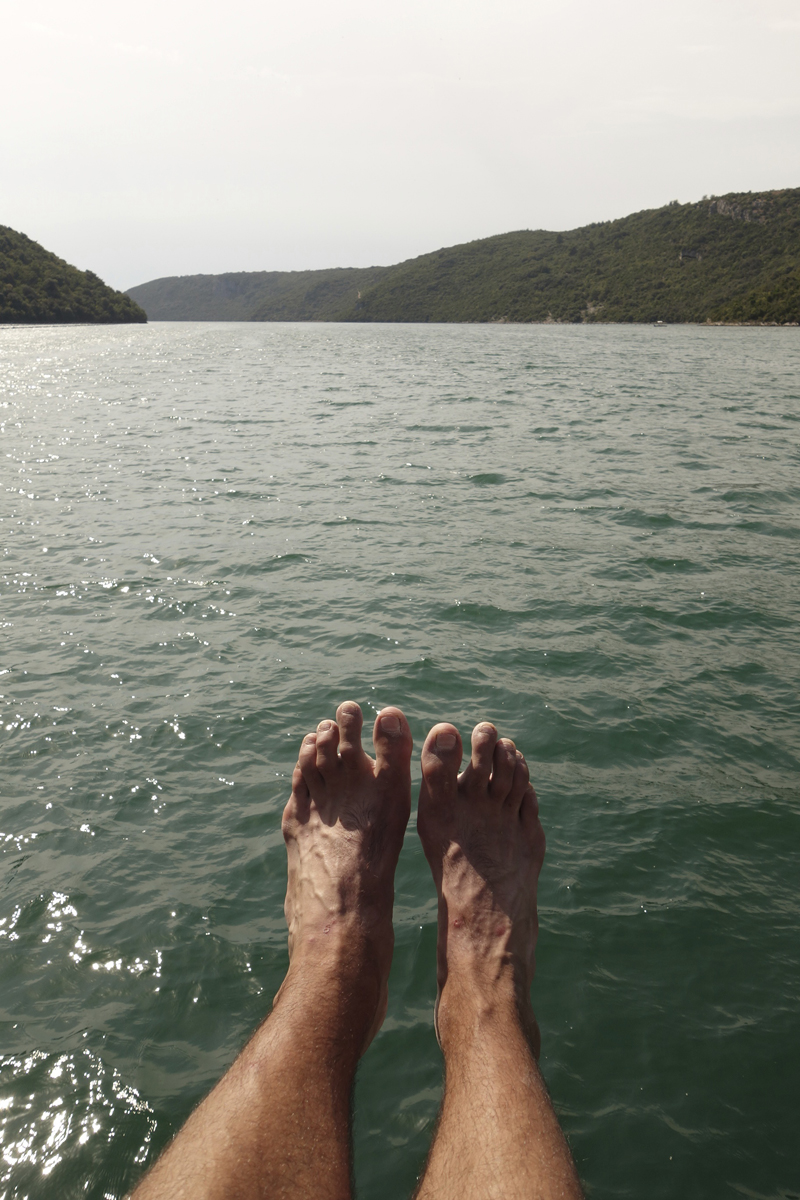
[132,702,411,1200]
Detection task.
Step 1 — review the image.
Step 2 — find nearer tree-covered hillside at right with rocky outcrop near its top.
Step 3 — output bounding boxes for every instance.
[347,188,800,324]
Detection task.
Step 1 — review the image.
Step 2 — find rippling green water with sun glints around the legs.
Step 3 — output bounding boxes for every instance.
[0,325,800,1200]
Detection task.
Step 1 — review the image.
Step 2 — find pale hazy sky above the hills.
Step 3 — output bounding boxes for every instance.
[0,0,800,287]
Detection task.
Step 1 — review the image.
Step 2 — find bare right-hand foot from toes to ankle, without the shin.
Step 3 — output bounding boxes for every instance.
[417,722,545,1057]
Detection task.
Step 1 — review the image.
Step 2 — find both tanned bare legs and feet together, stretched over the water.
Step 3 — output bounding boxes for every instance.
[131,701,582,1200]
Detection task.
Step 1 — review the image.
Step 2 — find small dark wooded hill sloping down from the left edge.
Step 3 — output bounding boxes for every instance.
[0,226,148,325]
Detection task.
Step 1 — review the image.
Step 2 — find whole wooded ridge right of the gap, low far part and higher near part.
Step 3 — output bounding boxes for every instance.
[128,188,800,324]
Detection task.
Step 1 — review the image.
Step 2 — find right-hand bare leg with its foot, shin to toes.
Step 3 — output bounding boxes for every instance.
[417,724,582,1200]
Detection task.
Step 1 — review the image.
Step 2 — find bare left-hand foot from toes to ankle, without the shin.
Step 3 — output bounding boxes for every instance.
[276,701,411,1054]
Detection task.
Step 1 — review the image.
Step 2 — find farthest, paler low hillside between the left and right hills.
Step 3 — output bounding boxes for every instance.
[127,266,389,320]
